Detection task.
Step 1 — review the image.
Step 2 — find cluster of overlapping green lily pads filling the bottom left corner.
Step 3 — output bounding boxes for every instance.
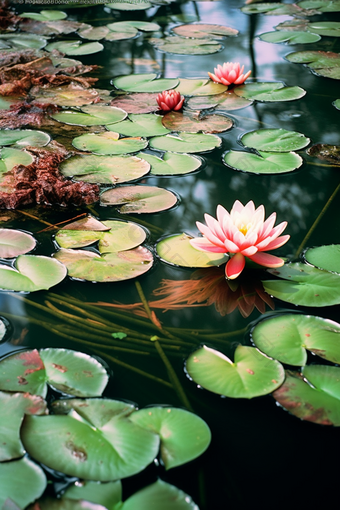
[0,348,211,510]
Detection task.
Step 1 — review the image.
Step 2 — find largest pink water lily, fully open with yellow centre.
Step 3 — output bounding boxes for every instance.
[190,200,290,279]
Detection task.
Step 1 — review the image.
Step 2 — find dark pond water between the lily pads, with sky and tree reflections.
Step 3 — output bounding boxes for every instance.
[0,0,340,510]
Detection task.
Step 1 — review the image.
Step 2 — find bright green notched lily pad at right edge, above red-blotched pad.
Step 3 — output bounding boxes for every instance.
[252,314,340,366]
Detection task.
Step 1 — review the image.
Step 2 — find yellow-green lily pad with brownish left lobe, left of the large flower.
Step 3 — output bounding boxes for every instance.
[55,220,146,253]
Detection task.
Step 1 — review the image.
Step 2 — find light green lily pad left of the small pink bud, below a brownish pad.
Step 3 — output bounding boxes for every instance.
[51,105,127,126]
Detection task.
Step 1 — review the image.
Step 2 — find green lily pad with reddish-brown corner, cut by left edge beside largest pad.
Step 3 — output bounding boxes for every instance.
[0,391,47,462]
